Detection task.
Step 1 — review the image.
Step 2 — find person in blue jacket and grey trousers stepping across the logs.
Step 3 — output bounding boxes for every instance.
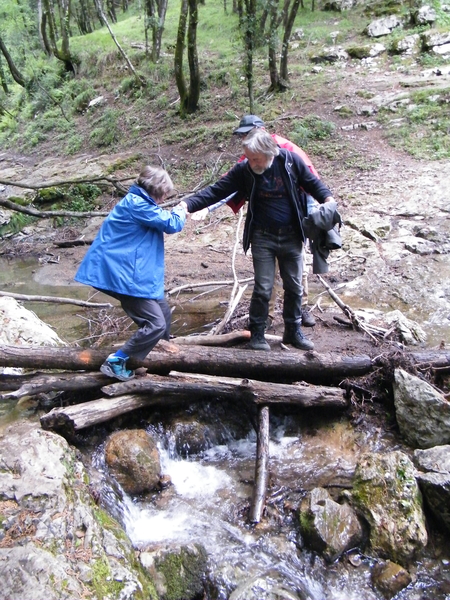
[75,166,186,381]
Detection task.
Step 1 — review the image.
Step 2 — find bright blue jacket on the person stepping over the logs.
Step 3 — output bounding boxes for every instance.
[75,185,186,300]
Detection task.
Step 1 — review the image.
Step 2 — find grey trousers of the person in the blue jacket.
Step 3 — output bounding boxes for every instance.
[100,290,172,360]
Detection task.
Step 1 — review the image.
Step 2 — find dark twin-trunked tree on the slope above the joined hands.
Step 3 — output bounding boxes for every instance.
[174,0,200,116]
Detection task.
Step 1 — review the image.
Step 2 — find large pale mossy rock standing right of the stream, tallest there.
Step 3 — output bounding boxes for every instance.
[352,451,428,564]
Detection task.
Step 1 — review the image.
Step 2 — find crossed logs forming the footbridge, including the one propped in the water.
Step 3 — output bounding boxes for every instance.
[0,336,450,522]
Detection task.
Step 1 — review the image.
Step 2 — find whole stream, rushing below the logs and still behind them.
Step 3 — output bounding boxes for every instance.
[0,254,450,600]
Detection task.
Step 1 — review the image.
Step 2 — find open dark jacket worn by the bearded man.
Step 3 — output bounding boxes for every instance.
[186,149,332,252]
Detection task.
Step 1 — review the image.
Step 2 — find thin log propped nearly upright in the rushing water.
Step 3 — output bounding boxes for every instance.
[249,405,270,523]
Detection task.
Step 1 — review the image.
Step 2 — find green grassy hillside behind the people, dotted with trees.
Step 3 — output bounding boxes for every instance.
[0,0,450,176]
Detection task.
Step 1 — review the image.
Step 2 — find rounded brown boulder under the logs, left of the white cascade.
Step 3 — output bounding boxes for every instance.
[105,429,161,494]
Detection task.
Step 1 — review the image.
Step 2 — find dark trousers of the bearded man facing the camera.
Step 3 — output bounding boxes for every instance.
[249,229,303,331]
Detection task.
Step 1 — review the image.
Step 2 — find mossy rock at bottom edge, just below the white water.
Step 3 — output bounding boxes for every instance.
[140,544,207,600]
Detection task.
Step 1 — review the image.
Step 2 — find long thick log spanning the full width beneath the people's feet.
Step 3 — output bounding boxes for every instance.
[0,343,450,385]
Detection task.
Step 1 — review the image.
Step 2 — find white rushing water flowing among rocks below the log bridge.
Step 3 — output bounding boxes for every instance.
[89,415,450,600]
